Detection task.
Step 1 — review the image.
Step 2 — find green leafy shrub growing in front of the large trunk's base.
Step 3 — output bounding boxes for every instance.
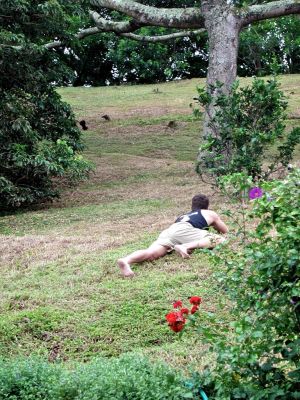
[198,79,300,178]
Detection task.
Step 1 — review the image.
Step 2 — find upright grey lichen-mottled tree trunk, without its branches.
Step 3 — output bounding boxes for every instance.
[202,0,241,137]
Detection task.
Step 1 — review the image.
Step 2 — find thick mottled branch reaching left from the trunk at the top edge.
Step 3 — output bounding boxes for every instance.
[90,0,204,29]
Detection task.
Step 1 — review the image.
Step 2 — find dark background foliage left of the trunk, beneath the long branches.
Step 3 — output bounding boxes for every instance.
[73,0,208,86]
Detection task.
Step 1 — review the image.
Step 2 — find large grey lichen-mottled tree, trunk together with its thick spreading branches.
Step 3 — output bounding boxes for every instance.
[79,0,300,135]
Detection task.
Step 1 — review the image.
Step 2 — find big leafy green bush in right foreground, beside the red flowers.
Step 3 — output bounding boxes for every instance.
[192,170,300,400]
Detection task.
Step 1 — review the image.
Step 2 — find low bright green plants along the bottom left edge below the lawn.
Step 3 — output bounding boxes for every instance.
[0,355,193,400]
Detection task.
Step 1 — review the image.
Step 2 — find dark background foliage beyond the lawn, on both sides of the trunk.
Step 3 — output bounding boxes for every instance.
[67,0,300,86]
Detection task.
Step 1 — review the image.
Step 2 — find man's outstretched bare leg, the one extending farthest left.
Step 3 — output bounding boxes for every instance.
[118,244,168,278]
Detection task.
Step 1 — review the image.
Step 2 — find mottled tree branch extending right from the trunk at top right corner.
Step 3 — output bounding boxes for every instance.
[240,0,300,26]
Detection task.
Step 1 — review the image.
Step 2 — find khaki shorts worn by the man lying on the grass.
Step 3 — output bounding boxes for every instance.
[154,222,220,249]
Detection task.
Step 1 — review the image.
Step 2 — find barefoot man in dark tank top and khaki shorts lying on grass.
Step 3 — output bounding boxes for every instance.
[118,194,228,277]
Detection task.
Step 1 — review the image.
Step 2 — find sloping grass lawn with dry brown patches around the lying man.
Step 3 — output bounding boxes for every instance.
[0,75,300,368]
